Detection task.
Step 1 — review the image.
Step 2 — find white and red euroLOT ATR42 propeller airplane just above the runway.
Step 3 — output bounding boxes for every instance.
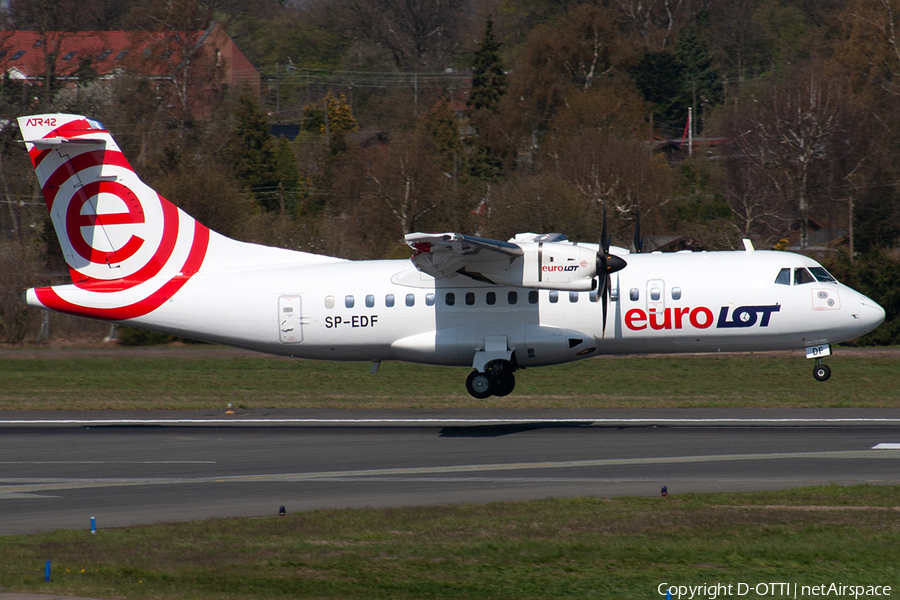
[18,114,885,399]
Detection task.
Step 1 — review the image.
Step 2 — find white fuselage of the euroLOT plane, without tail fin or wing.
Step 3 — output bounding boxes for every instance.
[84,240,884,367]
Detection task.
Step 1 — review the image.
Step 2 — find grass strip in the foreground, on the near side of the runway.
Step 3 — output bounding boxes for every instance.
[0,486,900,600]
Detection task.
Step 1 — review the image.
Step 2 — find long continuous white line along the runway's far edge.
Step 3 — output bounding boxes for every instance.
[0,417,900,427]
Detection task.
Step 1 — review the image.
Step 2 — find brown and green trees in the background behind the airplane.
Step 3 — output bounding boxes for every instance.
[0,0,900,343]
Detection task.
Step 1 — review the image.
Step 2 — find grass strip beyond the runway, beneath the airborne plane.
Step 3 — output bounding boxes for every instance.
[0,348,900,410]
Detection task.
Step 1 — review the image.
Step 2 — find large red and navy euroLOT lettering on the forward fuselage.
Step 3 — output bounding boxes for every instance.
[625,304,781,331]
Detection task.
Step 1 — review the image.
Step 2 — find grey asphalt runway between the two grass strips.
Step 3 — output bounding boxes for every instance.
[0,409,900,535]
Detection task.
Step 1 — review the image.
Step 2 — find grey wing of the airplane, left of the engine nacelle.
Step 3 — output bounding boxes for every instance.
[406,233,525,283]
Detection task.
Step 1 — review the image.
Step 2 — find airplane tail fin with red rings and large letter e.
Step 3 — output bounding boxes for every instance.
[18,114,210,320]
